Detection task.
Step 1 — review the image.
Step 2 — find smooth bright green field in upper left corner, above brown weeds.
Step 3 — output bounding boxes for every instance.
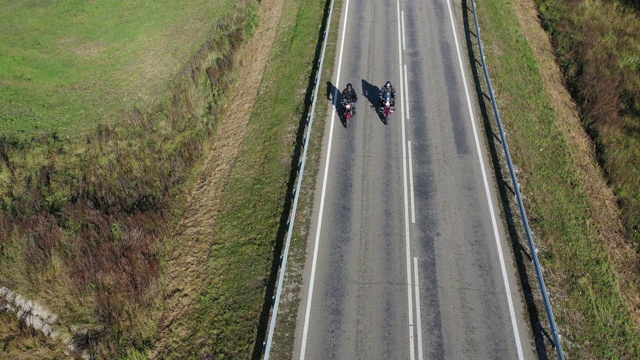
[0,0,234,134]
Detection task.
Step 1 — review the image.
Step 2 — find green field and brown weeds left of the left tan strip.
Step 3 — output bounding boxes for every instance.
[0,0,256,358]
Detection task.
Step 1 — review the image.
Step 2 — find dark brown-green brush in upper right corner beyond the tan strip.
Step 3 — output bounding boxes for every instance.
[536,0,640,249]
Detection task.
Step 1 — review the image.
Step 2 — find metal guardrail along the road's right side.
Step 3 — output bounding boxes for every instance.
[471,0,564,360]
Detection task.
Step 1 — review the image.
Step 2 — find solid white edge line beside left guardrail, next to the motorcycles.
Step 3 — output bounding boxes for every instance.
[300,0,349,360]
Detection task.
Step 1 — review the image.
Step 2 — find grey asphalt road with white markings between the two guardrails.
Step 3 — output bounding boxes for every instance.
[294,0,534,359]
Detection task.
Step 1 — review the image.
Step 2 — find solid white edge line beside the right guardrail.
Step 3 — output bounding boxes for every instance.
[447,0,524,360]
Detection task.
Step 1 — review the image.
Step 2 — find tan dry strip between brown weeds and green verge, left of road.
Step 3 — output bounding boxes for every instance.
[154,0,284,357]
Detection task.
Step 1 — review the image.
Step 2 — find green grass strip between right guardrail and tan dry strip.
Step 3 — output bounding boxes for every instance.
[478,0,640,359]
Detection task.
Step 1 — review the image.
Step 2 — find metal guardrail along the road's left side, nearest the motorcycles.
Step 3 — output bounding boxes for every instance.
[263,0,334,360]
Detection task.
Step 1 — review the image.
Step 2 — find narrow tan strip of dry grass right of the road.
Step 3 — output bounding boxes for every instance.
[514,0,640,326]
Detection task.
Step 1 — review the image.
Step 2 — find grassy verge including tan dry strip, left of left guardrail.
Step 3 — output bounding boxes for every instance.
[152,0,326,358]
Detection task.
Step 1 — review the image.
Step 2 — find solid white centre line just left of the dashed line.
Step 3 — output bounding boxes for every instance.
[396,0,415,360]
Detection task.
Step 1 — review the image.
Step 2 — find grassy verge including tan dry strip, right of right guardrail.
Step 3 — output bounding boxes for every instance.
[478,1,640,359]
